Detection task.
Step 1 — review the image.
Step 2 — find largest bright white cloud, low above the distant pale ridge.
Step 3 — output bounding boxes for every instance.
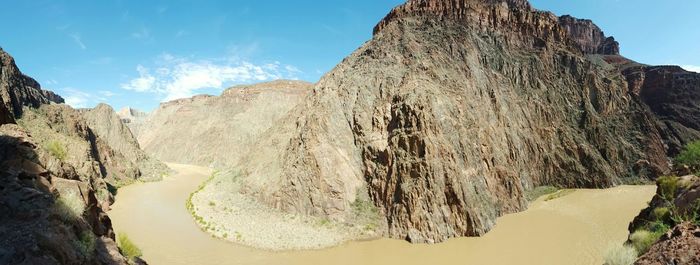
[121,54,301,101]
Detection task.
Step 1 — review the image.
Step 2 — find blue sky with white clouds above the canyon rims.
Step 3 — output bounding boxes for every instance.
[0,0,700,111]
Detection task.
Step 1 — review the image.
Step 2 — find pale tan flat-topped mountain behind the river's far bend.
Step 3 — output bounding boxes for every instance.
[131,80,311,167]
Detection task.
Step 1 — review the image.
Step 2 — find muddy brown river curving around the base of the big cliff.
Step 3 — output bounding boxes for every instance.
[109,164,655,265]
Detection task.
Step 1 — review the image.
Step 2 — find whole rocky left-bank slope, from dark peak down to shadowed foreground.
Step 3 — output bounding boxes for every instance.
[0,48,140,264]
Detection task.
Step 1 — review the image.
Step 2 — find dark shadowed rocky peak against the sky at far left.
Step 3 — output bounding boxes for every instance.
[0,49,64,117]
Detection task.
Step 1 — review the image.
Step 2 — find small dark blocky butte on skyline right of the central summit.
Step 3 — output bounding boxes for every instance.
[559,15,620,55]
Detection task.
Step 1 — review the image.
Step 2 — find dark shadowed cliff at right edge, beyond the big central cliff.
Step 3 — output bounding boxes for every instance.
[622,65,700,156]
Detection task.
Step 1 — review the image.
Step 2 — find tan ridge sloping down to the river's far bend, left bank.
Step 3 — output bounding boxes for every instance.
[81,104,170,181]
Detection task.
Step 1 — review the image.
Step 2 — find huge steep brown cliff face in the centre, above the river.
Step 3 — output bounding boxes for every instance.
[230,0,668,242]
